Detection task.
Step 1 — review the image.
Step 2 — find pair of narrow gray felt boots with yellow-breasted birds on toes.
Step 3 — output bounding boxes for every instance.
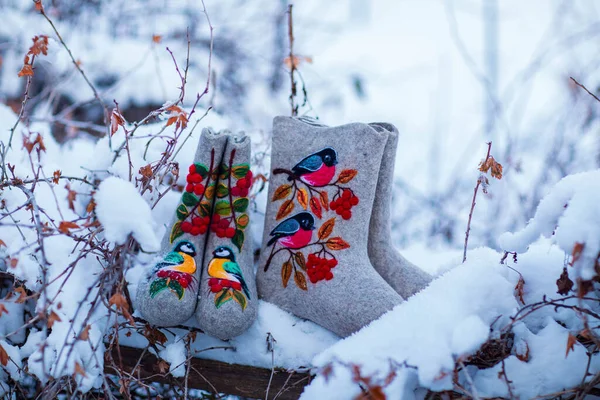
[136,129,258,339]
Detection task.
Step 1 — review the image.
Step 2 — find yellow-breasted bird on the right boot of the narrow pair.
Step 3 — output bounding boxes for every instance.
[208,246,250,299]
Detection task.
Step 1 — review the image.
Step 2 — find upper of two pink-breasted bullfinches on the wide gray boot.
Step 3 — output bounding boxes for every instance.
[288,147,338,187]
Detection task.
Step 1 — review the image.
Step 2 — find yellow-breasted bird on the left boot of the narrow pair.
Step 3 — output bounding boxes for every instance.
[150,240,196,299]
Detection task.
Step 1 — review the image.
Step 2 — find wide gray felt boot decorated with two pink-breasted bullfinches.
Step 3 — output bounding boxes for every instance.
[257,117,402,337]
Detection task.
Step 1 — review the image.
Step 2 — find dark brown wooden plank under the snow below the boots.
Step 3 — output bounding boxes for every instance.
[105,346,311,400]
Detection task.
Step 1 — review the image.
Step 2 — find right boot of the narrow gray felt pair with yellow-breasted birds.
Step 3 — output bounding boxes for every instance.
[196,134,258,340]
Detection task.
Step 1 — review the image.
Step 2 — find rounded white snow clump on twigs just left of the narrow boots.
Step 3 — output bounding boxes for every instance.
[94,177,160,252]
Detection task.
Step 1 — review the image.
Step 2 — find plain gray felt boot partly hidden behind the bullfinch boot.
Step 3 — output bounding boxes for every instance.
[369,123,432,299]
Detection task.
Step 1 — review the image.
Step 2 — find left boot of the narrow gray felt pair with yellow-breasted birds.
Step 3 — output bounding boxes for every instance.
[136,129,227,326]
